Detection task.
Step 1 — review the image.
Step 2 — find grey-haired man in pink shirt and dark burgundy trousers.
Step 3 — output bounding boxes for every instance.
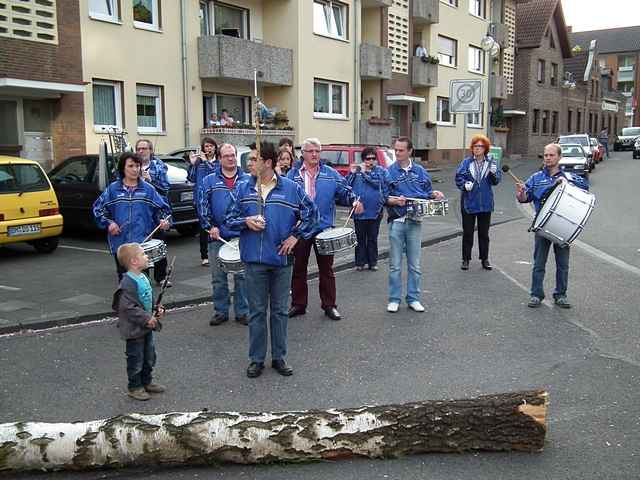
[287,138,363,320]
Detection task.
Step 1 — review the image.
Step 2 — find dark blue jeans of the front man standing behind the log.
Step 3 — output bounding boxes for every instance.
[245,263,292,363]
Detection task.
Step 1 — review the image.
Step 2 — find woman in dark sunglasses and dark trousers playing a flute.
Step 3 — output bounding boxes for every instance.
[347,147,386,271]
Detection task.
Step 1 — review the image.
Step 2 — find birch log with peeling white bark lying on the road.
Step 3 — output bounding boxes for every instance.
[0,390,548,471]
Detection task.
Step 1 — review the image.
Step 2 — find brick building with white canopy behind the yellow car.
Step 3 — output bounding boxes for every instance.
[0,0,85,169]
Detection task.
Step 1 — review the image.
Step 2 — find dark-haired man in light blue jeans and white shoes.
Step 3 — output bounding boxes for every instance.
[387,137,444,313]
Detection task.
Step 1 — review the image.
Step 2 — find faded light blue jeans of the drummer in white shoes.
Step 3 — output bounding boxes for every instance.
[389,219,422,303]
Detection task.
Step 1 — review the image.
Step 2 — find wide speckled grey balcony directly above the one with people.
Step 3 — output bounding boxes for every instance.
[198,35,293,86]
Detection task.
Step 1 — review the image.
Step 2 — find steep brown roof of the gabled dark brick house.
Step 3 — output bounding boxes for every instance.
[516,0,571,58]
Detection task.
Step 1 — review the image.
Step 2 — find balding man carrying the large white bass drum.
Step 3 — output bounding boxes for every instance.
[516,143,589,308]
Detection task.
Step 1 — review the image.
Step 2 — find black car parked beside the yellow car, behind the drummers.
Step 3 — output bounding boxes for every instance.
[49,154,199,236]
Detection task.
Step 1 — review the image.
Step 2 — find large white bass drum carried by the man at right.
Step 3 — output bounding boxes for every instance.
[529,182,596,247]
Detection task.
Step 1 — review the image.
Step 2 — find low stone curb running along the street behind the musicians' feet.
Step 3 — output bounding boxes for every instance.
[0,216,525,335]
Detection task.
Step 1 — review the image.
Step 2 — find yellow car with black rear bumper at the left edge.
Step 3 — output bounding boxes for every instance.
[0,155,62,253]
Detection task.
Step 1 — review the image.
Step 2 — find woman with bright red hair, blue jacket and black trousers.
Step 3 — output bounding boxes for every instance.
[455,135,502,270]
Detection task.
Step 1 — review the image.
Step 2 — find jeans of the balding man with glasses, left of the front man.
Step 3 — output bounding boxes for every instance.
[209,240,249,318]
